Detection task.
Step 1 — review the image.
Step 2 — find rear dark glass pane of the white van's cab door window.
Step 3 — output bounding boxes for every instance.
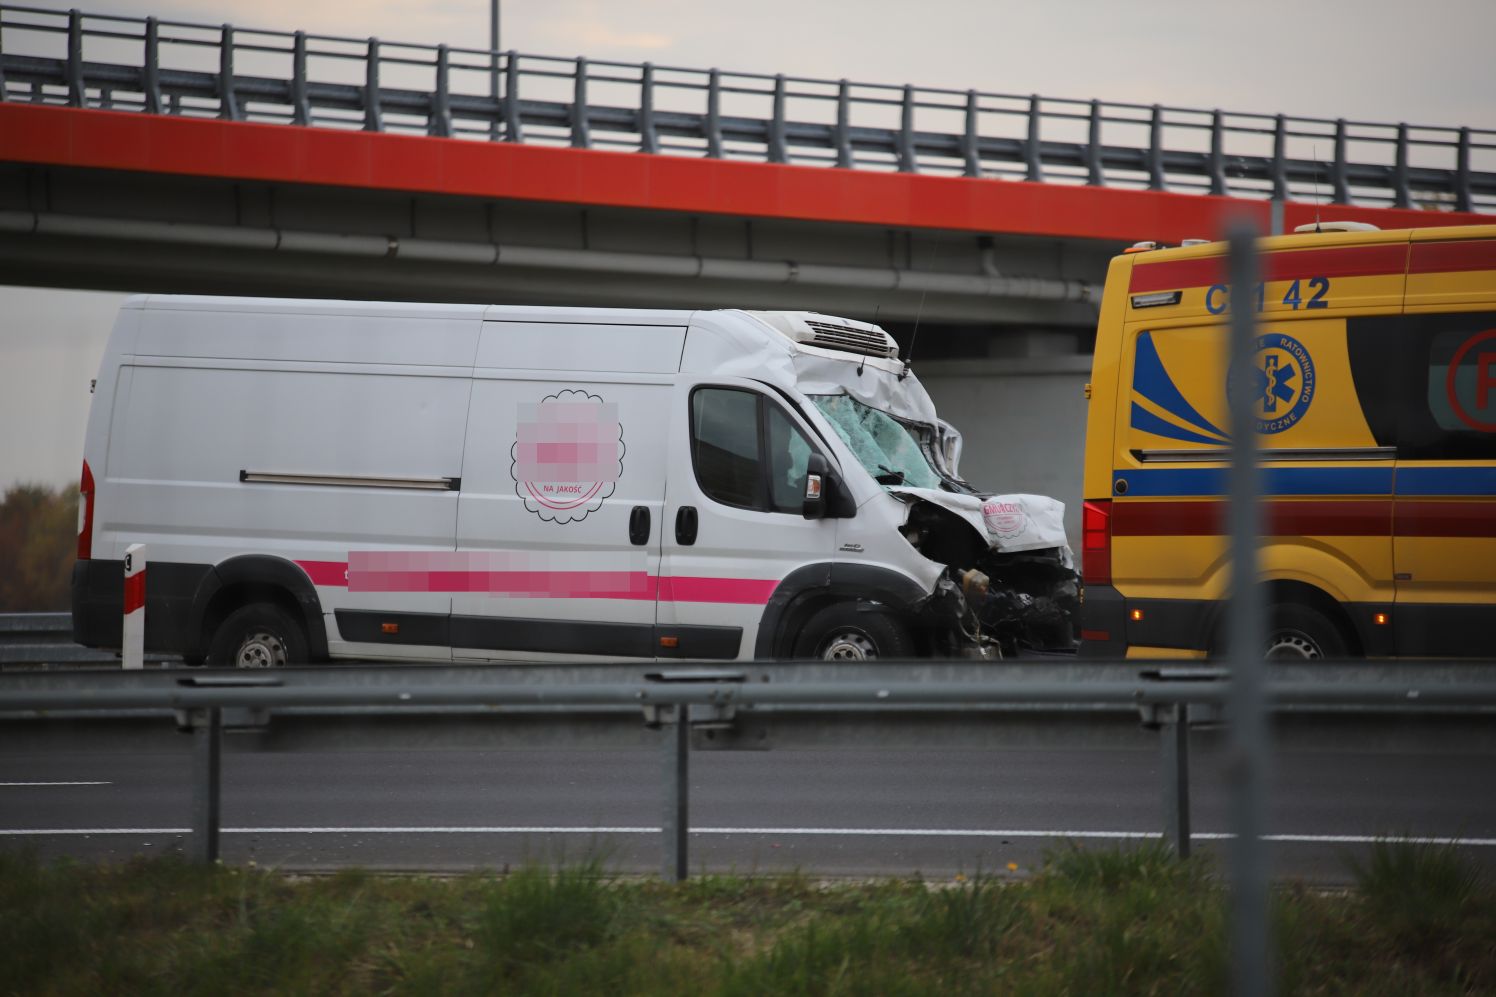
[691,388,763,509]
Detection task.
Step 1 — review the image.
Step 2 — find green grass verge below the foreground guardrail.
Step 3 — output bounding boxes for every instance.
[0,843,1496,996]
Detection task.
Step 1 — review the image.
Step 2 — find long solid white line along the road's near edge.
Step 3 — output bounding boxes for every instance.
[0,825,1496,847]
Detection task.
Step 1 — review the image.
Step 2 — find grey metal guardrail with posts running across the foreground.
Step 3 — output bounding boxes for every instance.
[0,662,1496,880]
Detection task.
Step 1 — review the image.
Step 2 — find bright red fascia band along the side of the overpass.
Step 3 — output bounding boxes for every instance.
[0,103,1492,243]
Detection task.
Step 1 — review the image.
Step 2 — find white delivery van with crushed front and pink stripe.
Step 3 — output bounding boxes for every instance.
[73,295,1079,666]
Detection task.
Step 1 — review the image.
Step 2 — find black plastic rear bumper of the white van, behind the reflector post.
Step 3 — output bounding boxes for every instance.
[73,560,212,654]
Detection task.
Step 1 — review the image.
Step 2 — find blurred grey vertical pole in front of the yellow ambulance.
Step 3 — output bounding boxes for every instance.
[1227,222,1272,997]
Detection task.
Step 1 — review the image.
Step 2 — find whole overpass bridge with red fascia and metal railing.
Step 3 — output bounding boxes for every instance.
[0,4,1496,531]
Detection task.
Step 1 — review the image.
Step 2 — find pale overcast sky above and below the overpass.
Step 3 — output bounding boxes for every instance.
[0,0,1496,488]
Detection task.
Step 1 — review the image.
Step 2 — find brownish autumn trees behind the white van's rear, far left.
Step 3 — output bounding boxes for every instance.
[0,485,78,612]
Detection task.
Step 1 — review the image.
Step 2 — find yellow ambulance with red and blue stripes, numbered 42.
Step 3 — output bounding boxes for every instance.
[1082,223,1496,660]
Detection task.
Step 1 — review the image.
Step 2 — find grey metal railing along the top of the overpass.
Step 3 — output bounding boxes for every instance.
[0,4,1496,211]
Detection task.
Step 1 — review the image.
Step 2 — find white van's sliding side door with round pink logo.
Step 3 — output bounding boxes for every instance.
[450,322,684,660]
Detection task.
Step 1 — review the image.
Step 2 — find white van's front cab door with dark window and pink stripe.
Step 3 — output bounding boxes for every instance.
[657,377,836,659]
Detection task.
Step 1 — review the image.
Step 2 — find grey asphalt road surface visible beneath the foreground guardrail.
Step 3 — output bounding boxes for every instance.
[0,734,1496,883]
